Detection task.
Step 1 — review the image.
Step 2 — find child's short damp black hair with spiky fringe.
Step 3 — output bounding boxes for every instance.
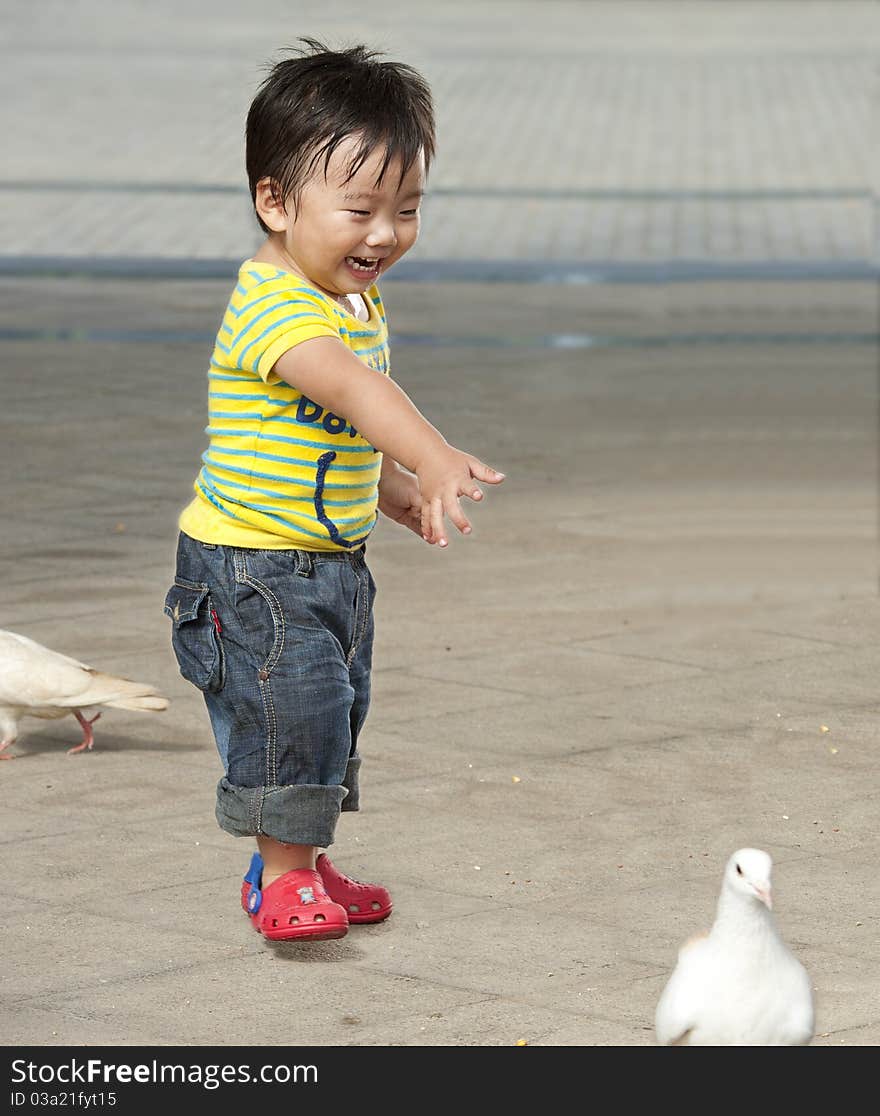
[245,38,435,232]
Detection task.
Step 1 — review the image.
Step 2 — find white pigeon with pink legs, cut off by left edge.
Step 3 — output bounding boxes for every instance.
[0,628,168,760]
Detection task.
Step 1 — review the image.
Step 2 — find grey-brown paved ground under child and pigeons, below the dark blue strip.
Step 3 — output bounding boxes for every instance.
[0,274,880,1045]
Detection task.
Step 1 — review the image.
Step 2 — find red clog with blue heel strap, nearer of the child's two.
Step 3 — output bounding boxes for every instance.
[241,853,348,942]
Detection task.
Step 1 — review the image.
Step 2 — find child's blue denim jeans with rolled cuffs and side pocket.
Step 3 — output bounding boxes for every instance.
[165,533,376,847]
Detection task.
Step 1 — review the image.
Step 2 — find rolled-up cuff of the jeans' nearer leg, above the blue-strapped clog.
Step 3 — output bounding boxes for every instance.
[216,776,347,848]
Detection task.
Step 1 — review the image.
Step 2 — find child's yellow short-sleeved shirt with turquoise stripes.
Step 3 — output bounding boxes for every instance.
[180,260,388,550]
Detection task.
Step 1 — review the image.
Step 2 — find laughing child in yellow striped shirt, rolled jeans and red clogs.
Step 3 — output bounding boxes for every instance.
[165,39,503,940]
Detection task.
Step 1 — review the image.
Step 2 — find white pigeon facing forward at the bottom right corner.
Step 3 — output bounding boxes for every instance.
[655,848,814,1046]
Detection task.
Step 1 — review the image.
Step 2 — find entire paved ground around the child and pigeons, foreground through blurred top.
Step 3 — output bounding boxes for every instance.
[0,2,880,1046]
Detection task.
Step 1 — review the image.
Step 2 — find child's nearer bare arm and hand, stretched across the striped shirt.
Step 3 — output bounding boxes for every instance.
[273,337,504,547]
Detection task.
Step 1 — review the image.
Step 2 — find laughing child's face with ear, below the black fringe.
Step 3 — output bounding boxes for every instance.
[264,137,425,295]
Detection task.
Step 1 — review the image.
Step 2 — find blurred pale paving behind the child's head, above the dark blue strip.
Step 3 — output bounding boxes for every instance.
[0,0,878,270]
